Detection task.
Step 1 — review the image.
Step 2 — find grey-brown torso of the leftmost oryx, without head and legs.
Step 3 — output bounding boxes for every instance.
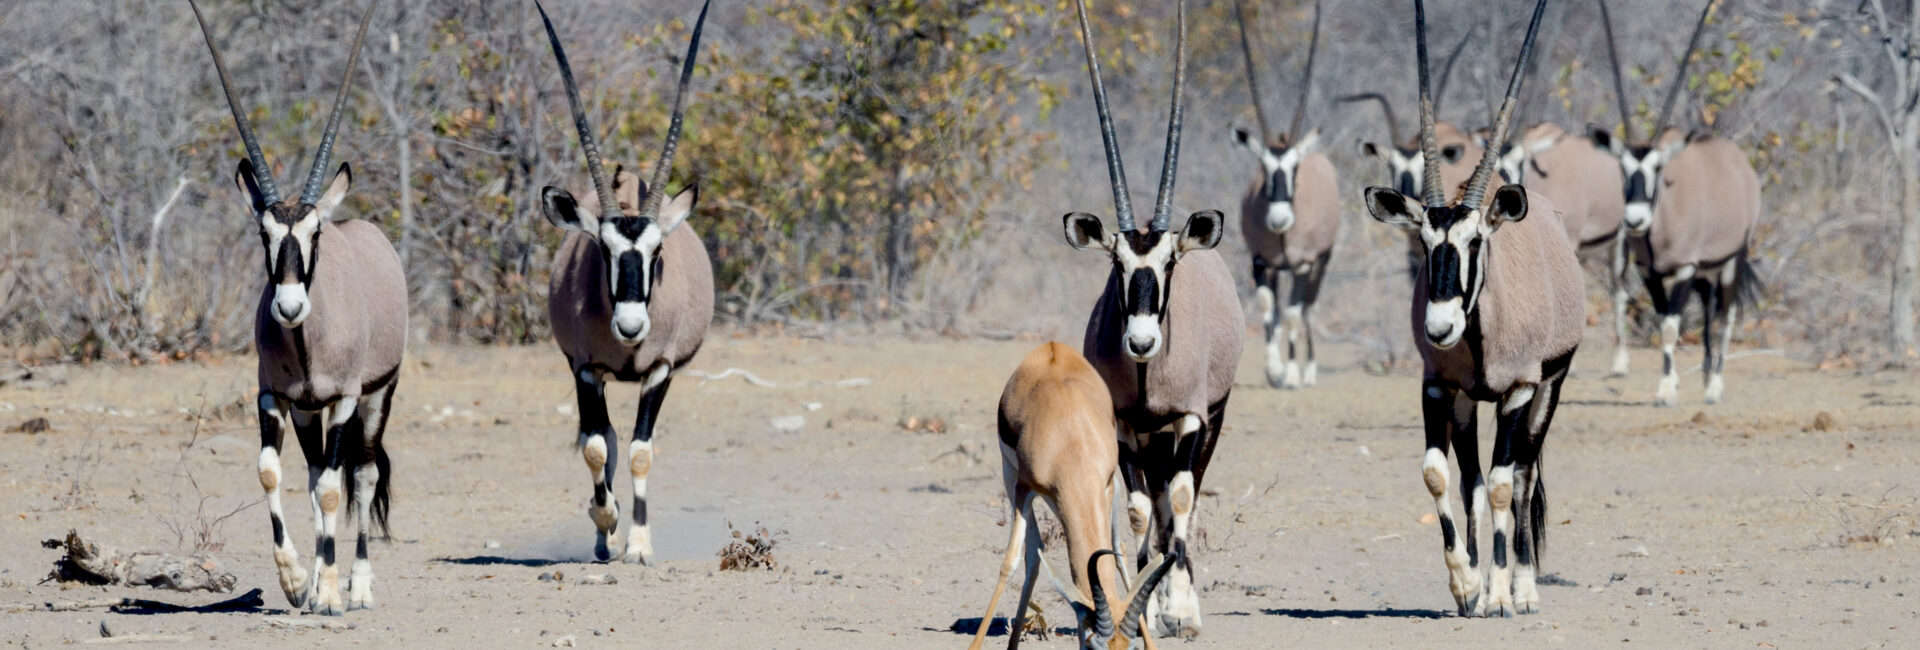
[253,219,407,403]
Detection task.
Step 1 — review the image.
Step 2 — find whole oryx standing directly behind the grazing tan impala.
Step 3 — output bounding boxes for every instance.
[1062,0,1242,637]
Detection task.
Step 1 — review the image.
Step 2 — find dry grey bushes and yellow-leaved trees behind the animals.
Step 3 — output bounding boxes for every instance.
[0,0,1910,364]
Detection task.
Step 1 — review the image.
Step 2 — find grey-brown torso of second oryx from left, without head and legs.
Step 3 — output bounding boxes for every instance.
[547,226,714,382]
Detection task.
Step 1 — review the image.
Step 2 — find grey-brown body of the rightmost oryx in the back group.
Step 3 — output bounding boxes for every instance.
[1647,138,1761,272]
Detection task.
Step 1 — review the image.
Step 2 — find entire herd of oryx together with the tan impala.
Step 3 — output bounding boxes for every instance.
[190,0,1761,648]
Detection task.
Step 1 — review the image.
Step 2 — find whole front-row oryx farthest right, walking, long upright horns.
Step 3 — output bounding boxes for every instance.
[1365,0,1586,615]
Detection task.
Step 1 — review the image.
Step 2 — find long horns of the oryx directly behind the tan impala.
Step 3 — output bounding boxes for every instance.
[1073,0,1187,232]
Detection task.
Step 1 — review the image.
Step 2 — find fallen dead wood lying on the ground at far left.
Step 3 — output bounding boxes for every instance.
[42,531,236,592]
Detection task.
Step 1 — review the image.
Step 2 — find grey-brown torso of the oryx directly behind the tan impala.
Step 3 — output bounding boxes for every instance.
[1081,249,1246,416]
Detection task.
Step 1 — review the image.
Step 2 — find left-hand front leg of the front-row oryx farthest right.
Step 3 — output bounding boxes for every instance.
[1421,382,1486,615]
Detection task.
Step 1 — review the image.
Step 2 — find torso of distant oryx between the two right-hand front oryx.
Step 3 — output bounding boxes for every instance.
[1240,151,1340,265]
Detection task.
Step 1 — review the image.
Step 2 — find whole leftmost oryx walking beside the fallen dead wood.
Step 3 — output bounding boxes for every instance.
[188,2,407,615]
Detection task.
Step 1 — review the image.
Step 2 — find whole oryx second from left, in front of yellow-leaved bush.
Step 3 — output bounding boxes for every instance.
[536,2,714,564]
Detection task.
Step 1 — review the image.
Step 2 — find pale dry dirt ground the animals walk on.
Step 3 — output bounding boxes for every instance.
[0,336,1920,648]
